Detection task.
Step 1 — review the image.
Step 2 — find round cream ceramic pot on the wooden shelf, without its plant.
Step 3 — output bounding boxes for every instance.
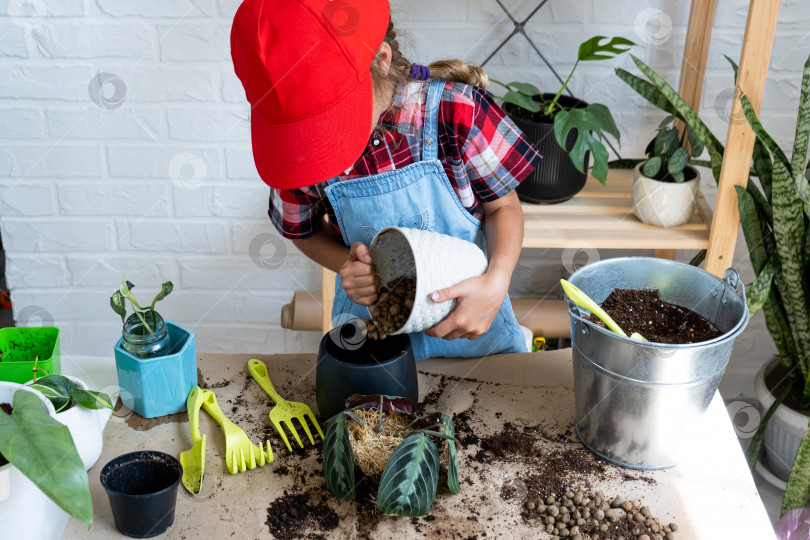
[633,162,700,227]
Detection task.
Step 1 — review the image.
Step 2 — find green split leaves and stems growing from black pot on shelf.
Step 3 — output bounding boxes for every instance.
[490,36,635,184]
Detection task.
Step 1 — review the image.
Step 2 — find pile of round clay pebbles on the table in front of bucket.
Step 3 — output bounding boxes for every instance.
[521,490,678,540]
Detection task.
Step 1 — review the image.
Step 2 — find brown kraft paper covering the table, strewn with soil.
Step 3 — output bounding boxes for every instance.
[63,349,773,540]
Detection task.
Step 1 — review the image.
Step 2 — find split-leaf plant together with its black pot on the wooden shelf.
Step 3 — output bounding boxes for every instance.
[493,36,634,203]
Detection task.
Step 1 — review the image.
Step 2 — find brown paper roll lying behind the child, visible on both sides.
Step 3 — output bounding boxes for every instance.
[281,291,571,338]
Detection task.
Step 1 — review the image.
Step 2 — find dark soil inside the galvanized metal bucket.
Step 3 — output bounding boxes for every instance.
[589,289,721,344]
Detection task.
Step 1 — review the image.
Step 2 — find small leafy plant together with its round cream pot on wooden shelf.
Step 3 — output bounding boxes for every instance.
[633,115,703,227]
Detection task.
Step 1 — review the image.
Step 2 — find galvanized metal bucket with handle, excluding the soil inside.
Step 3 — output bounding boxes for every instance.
[568,257,748,469]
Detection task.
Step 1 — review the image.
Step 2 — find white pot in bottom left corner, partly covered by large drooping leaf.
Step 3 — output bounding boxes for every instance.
[0,382,68,540]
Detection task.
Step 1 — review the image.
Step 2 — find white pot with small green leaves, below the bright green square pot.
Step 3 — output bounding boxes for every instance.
[28,375,113,470]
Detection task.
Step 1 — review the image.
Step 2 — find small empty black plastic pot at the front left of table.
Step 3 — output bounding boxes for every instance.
[101,450,183,538]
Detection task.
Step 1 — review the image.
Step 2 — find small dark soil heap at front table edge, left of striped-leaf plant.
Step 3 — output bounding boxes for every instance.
[265,491,340,538]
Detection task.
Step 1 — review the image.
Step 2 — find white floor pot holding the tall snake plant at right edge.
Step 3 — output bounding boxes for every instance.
[754,358,808,489]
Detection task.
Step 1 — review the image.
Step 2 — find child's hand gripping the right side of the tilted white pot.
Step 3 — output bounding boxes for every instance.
[425,273,509,340]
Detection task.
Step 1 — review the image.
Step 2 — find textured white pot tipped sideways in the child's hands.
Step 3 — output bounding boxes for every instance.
[369,227,487,334]
